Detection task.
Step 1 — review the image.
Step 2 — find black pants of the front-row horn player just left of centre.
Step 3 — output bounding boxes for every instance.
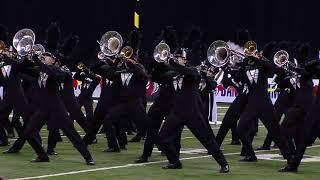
[104,99,147,148]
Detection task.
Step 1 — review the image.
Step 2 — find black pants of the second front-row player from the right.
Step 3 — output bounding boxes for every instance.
[237,95,287,156]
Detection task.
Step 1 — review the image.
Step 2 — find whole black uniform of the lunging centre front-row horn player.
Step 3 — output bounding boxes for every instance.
[158,58,229,172]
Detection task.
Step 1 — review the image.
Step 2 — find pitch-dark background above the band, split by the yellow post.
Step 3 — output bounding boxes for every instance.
[0,0,320,62]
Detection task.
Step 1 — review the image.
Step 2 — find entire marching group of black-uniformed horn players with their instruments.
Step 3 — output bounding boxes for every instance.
[0,26,320,173]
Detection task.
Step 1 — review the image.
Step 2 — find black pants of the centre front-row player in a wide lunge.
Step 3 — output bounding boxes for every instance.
[158,111,228,166]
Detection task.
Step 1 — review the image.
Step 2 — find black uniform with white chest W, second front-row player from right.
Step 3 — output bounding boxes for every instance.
[237,56,288,162]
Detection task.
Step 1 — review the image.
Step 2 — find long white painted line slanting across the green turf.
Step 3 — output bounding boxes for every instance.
[8,145,320,180]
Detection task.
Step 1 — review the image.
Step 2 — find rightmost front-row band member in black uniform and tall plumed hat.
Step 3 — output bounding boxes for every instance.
[280,44,318,172]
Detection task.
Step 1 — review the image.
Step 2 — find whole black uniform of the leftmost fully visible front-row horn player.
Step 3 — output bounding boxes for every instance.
[21,58,94,165]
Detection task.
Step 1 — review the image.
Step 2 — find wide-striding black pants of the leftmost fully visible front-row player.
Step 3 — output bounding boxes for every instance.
[25,111,91,160]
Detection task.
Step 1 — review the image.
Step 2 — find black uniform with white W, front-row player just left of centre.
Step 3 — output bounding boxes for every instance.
[104,59,147,152]
